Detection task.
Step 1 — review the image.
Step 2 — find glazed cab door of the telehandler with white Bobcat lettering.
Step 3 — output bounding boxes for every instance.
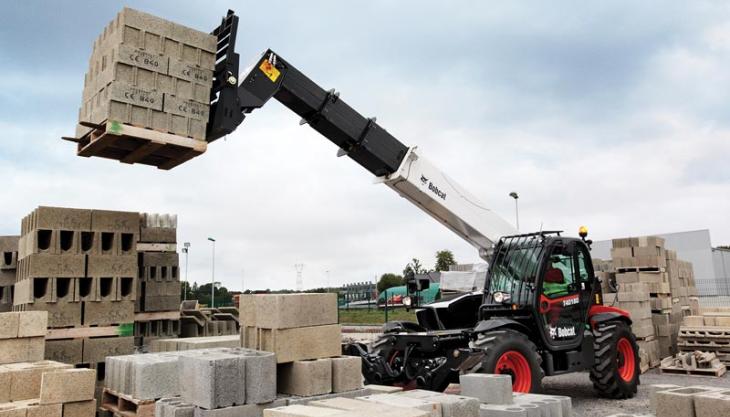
[537,241,585,348]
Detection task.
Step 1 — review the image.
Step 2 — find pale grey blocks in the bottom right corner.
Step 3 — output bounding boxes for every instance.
[650,385,730,417]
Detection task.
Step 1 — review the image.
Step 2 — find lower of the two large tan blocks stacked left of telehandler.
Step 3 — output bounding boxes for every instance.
[256,324,342,363]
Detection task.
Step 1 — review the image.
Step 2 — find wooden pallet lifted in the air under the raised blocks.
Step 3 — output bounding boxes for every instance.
[63,121,208,170]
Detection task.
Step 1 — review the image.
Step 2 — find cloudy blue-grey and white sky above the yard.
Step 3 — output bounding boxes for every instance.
[0,0,730,289]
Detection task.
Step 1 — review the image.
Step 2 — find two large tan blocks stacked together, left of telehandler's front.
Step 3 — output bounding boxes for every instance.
[239,293,342,363]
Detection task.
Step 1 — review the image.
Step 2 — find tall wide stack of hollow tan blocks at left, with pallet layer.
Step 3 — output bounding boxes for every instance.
[13,207,139,392]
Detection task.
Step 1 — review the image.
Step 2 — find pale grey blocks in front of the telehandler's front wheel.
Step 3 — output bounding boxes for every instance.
[459,374,573,417]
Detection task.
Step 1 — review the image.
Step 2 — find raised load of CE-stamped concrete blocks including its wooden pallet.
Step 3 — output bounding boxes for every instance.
[68,8,217,169]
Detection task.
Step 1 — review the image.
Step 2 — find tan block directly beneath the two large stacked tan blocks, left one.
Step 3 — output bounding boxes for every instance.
[277,359,332,397]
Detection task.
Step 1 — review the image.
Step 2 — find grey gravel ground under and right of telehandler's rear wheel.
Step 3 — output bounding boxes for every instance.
[543,369,730,417]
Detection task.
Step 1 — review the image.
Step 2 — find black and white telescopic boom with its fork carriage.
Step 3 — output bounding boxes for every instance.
[207,11,516,259]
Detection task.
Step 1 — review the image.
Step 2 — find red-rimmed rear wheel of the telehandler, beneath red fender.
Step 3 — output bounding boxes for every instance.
[591,321,641,399]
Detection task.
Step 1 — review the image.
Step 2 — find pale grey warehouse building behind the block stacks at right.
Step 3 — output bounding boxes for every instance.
[591,229,730,296]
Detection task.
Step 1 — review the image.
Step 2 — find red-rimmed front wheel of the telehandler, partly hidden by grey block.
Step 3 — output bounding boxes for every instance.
[472,330,545,393]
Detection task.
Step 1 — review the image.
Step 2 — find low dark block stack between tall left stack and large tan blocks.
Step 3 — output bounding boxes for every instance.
[180,302,240,337]
